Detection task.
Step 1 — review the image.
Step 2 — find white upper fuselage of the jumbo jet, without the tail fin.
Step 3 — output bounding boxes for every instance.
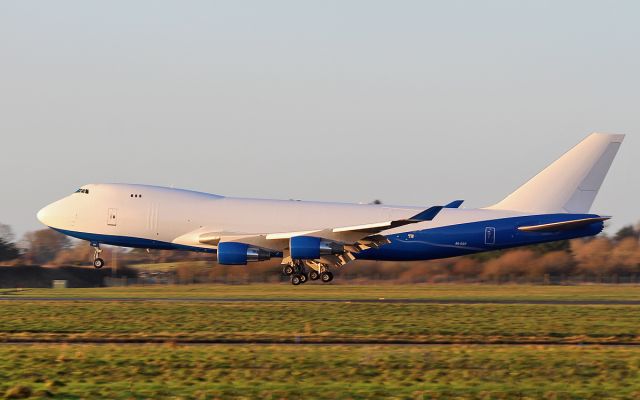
[38,184,522,250]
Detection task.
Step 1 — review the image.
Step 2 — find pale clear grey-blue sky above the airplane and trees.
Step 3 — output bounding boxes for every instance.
[0,0,640,235]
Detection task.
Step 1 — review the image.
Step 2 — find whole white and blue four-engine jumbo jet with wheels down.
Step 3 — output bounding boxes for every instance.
[37,133,624,285]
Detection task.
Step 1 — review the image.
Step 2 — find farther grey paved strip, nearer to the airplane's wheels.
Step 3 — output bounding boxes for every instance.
[0,296,640,306]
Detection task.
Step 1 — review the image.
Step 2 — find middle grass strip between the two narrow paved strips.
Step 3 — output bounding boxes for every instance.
[0,301,640,343]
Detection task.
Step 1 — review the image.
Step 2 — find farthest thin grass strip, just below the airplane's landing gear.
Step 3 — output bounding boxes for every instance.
[0,283,640,300]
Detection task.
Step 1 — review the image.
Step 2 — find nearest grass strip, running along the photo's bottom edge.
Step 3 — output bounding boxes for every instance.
[0,345,640,399]
